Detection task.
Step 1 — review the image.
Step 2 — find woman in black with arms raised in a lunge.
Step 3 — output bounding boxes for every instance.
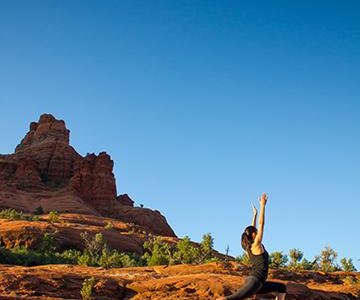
[217,193,286,300]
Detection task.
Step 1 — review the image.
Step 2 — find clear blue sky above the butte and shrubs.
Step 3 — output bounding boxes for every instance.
[0,0,360,268]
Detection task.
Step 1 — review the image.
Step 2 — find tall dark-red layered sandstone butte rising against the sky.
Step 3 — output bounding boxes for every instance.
[0,114,175,236]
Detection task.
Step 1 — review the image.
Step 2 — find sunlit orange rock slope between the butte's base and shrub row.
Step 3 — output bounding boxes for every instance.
[0,213,162,255]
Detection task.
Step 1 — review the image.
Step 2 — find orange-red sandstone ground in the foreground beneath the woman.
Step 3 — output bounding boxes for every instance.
[0,263,360,300]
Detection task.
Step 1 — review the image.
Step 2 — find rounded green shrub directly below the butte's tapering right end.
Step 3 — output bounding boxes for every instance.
[142,237,174,266]
